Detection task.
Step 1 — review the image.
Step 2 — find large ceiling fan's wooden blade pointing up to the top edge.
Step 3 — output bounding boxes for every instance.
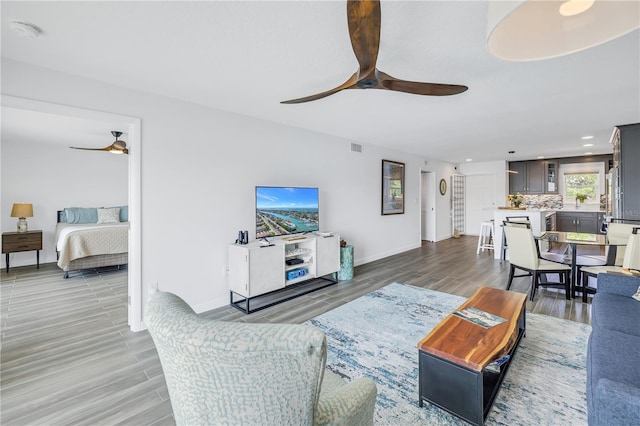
[347,0,381,79]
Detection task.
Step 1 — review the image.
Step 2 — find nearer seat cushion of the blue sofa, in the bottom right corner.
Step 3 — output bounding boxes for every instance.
[587,329,640,425]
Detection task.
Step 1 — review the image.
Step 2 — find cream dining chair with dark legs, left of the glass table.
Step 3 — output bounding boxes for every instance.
[503,225,571,300]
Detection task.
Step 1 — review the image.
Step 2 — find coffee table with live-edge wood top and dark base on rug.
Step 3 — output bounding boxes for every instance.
[418,287,527,425]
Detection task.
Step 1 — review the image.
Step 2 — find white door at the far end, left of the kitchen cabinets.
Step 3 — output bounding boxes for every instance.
[466,174,496,235]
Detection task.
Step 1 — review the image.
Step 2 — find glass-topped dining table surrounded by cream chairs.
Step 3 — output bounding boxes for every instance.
[537,231,620,298]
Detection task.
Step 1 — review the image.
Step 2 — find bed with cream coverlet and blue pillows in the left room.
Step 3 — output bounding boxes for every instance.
[55,206,129,278]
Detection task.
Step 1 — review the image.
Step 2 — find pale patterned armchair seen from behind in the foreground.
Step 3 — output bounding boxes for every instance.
[145,292,377,425]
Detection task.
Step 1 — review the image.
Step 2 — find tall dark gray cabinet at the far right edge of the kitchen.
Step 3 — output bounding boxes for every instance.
[611,123,640,220]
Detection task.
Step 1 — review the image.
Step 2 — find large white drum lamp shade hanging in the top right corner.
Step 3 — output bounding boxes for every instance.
[487,0,640,61]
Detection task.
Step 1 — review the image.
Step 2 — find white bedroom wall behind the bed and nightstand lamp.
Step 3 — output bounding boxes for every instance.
[0,136,128,267]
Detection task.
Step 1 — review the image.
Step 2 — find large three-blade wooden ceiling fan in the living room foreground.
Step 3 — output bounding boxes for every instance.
[280,0,468,104]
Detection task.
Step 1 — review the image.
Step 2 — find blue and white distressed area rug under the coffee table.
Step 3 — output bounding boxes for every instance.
[307,283,591,425]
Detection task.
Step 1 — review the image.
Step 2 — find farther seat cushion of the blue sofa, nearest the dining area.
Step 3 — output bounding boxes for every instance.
[591,293,640,337]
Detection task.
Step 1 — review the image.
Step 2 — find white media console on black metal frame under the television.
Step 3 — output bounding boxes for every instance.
[229,234,340,314]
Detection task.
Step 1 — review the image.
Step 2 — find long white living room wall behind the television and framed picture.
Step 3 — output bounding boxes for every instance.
[2,59,453,311]
